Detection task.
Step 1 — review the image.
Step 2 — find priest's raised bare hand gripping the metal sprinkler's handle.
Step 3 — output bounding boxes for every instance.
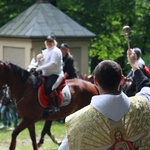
[127,49,140,71]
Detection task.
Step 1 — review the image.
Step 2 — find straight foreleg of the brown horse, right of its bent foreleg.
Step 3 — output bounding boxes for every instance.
[28,123,38,150]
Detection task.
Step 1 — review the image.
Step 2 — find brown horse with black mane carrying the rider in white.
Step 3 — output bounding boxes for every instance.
[0,61,98,150]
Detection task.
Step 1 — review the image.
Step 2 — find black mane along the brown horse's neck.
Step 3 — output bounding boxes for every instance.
[4,62,30,81]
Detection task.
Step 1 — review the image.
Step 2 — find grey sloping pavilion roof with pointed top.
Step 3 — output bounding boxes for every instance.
[0,0,95,38]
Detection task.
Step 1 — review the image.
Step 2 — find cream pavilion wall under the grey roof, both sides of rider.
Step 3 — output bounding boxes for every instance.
[0,38,90,74]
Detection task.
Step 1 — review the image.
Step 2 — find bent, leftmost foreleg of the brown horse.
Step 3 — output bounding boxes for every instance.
[9,120,34,150]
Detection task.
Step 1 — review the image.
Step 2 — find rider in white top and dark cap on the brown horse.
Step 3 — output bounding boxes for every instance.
[36,35,64,113]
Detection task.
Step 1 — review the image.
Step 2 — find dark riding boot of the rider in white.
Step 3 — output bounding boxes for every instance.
[49,90,60,113]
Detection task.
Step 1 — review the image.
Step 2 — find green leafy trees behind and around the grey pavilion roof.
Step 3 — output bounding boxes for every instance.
[0,0,150,73]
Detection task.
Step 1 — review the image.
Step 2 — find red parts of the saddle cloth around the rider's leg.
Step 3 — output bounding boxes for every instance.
[38,78,66,108]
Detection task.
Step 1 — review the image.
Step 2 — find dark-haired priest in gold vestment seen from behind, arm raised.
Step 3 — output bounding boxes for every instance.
[58,50,150,150]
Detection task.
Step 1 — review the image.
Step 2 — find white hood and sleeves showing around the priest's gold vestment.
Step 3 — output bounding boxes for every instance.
[58,87,150,150]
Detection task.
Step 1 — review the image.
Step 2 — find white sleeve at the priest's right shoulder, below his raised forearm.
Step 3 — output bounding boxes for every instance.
[136,87,150,106]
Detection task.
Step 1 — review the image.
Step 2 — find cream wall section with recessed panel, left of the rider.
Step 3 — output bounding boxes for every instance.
[0,38,32,69]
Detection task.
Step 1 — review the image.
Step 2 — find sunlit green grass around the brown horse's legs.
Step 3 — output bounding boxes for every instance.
[0,121,66,150]
